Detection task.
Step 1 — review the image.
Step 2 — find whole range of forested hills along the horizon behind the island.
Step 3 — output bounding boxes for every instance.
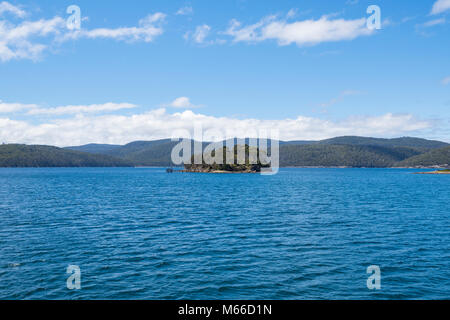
[4,136,450,171]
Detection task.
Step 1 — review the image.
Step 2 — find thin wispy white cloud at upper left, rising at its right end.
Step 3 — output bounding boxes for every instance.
[61,12,166,42]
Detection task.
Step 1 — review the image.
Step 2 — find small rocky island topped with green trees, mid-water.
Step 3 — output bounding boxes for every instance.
[182,145,270,173]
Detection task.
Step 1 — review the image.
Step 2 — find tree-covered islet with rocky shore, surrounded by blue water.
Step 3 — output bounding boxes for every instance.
[185,145,269,173]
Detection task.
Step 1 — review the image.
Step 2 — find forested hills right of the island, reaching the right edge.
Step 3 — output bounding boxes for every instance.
[280,137,450,168]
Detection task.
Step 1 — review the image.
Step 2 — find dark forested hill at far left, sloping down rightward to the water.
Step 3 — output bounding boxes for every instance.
[0,144,132,167]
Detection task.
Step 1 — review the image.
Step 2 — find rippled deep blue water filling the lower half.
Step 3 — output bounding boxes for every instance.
[0,168,450,299]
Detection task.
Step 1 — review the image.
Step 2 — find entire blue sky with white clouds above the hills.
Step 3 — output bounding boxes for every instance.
[0,0,450,146]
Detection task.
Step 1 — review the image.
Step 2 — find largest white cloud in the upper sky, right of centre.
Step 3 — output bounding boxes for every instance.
[224,16,374,46]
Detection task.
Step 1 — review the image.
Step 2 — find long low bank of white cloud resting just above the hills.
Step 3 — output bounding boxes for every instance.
[0,105,431,146]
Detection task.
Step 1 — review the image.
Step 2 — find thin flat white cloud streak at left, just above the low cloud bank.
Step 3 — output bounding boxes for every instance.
[27,102,137,115]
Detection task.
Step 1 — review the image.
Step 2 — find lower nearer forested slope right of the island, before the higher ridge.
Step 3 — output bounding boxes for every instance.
[280,145,420,167]
